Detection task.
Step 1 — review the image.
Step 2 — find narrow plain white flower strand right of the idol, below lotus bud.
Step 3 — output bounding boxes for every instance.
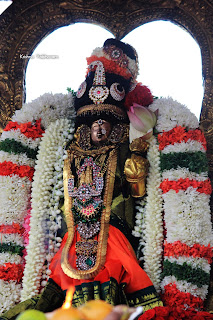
[143,137,163,292]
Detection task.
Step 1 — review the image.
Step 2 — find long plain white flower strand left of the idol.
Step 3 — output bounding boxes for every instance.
[21,119,74,301]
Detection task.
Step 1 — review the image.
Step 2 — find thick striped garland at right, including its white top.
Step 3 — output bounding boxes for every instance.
[148,99,213,310]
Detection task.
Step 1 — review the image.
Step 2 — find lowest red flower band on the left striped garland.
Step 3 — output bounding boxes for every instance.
[0,262,24,282]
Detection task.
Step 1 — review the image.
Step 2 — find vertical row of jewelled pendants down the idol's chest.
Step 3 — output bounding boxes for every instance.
[68,157,104,270]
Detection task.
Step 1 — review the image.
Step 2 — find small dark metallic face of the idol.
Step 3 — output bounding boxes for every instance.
[91,119,112,146]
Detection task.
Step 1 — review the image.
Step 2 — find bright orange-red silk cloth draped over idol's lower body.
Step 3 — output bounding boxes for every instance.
[50,225,153,293]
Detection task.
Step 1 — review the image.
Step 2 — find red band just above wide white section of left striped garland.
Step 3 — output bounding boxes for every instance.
[0,161,34,181]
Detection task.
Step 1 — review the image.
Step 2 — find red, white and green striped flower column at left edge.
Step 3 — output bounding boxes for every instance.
[0,120,44,312]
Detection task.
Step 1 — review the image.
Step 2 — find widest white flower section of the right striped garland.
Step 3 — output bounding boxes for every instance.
[163,187,213,246]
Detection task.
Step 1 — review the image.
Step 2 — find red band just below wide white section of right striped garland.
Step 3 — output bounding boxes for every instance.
[164,241,213,264]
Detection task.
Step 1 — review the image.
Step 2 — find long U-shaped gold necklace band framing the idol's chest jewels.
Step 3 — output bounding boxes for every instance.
[61,149,117,279]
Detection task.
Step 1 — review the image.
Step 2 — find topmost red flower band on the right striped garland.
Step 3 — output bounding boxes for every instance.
[158,126,207,150]
